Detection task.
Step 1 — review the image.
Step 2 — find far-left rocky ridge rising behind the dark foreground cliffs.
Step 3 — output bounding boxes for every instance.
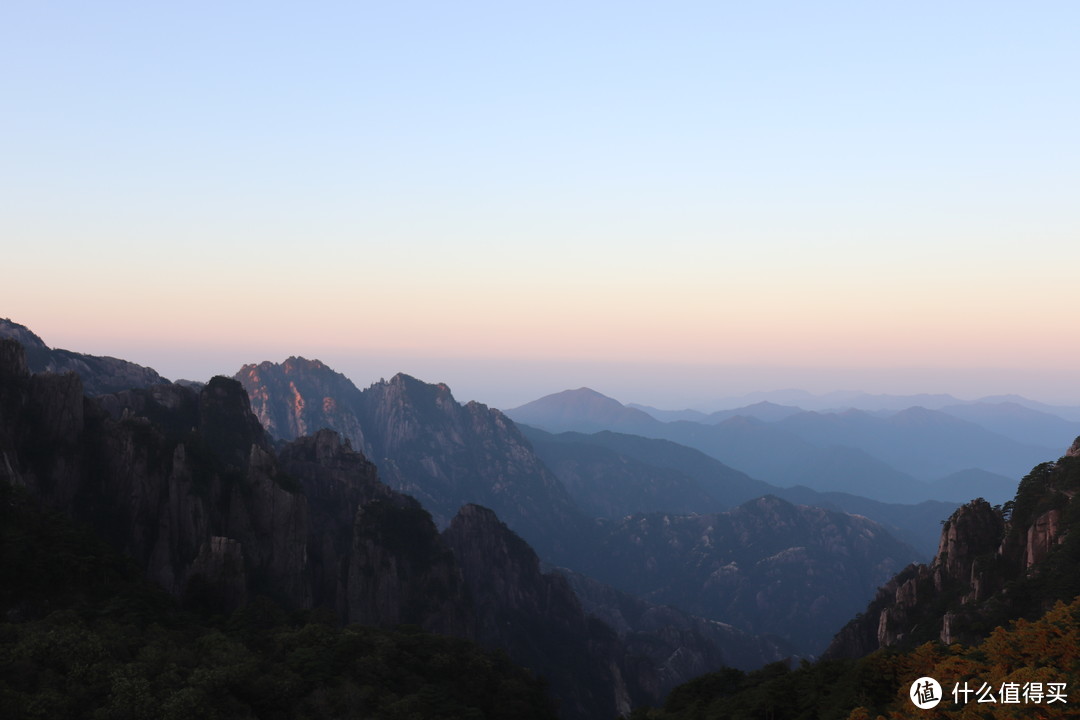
[0,317,168,395]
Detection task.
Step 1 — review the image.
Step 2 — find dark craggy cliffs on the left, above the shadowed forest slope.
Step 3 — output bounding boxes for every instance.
[0,340,474,637]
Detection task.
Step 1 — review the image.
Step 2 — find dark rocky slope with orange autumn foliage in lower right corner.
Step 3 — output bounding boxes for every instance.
[631,437,1080,720]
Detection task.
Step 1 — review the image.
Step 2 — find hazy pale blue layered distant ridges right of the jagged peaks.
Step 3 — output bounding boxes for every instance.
[507,389,1049,503]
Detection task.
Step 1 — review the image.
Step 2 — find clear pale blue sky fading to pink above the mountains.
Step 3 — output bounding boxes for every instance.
[0,0,1080,408]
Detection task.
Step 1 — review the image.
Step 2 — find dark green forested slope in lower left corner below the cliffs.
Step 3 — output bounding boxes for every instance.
[0,484,555,720]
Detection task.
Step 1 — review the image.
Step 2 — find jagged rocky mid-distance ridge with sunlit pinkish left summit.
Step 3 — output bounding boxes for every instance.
[235,357,588,559]
